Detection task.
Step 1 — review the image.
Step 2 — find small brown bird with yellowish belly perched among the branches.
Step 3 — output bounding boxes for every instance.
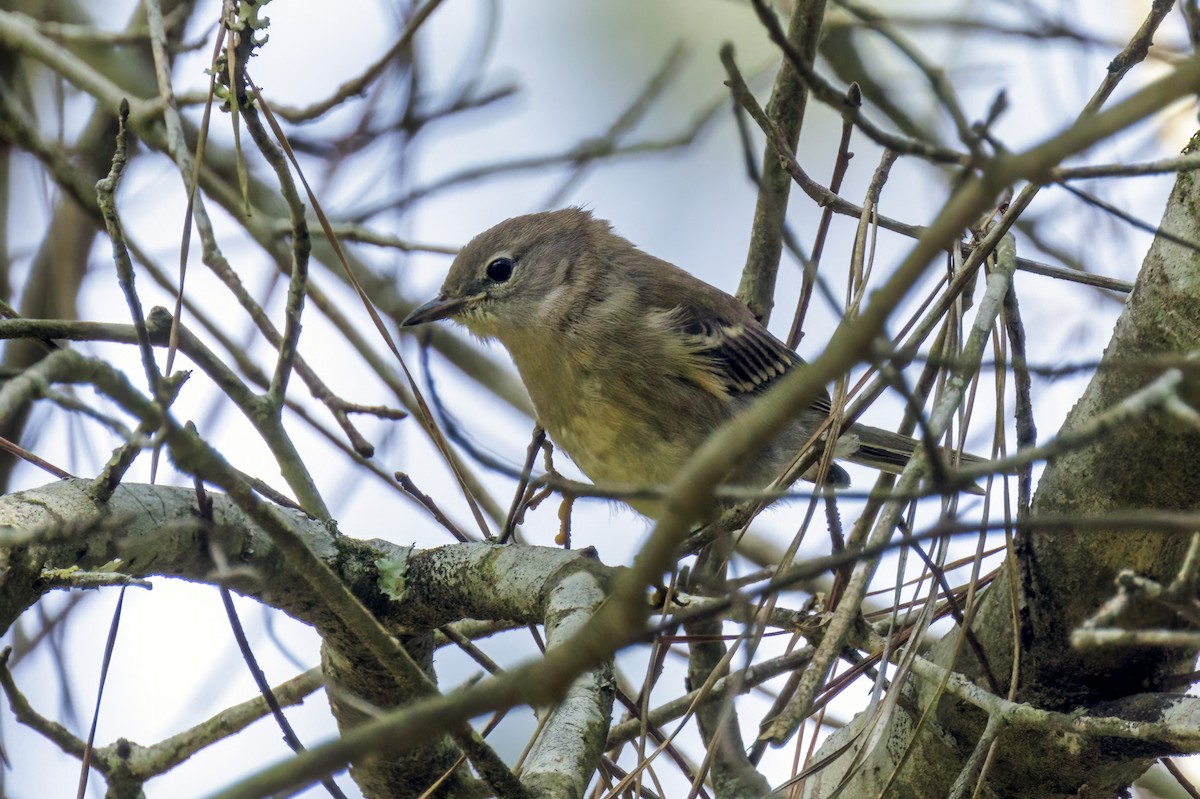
[401,208,974,512]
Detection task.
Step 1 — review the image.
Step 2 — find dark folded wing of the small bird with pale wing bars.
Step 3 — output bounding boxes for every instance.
[670,307,832,414]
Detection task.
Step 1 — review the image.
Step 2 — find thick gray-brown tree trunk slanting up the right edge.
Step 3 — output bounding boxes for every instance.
[804,133,1200,799]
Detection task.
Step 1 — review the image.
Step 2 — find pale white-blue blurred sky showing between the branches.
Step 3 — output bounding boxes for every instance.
[0,0,1194,799]
